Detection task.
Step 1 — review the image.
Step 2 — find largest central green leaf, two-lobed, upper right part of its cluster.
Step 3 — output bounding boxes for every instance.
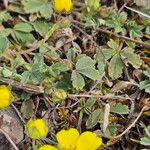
[76,56,99,80]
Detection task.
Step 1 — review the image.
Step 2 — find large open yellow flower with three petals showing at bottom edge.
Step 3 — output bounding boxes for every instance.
[36,128,103,150]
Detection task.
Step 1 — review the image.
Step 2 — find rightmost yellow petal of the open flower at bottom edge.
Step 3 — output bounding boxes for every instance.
[76,131,103,150]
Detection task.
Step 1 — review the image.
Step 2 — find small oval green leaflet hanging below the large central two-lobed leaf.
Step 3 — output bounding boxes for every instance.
[71,71,85,90]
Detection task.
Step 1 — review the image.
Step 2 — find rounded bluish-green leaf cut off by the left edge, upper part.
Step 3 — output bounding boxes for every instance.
[0,36,9,54]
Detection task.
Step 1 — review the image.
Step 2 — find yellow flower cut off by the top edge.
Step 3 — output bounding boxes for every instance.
[53,0,73,13]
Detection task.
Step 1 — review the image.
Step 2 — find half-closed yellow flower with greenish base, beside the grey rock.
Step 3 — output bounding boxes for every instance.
[26,119,48,139]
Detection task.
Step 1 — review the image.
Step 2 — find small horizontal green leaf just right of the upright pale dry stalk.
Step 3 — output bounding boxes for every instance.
[110,103,129,115]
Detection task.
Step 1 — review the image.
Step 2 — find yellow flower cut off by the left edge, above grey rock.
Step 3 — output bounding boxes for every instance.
[0,85,12,109]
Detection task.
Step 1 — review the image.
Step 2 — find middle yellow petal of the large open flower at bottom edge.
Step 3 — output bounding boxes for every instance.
[56,128,79,150]
